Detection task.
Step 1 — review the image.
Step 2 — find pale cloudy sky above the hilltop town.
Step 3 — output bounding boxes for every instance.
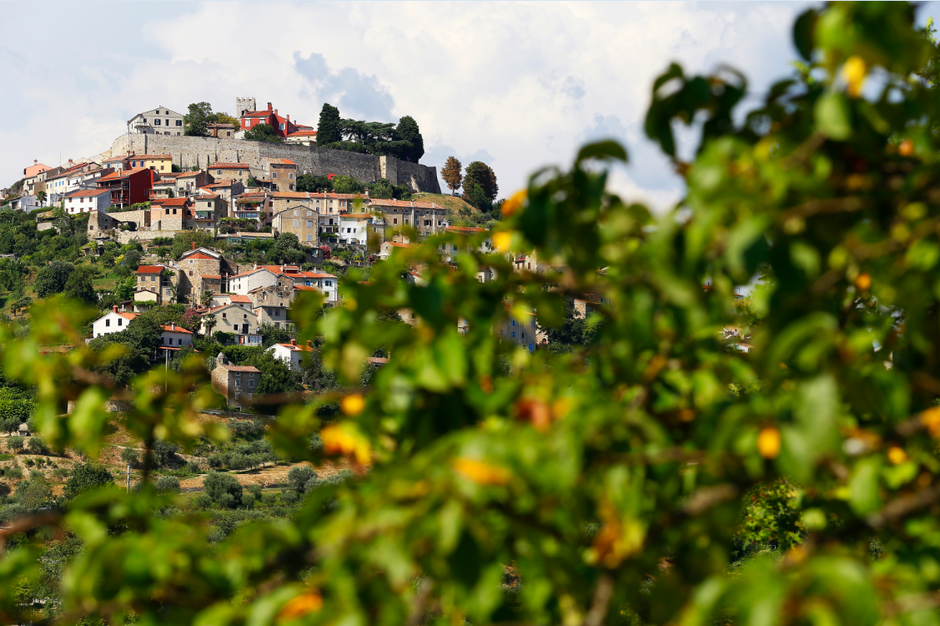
[0,1,940,208]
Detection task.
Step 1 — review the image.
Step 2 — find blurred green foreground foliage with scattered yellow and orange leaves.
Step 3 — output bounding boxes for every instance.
[0,3,940,626]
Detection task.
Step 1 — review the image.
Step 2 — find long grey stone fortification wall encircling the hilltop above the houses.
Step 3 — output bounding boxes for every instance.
[109,135,441,193]
